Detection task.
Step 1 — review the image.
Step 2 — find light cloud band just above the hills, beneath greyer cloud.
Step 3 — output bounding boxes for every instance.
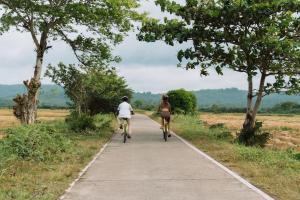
[118,65,247,93]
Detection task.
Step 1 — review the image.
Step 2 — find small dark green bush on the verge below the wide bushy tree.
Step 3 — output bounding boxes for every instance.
[66,112,96,132]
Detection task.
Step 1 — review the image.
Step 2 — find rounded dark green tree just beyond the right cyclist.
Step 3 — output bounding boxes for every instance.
[168,89,197,114]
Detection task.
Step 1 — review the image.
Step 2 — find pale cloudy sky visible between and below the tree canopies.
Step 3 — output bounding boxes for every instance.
[0,1,251,93]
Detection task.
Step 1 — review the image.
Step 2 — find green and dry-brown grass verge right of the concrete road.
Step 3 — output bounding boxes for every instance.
[151,115,300,200]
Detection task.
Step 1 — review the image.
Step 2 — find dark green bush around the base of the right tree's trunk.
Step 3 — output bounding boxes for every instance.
[236,121,271,147]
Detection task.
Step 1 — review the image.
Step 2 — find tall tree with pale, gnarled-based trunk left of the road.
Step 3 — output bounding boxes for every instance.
[0,0,140,124]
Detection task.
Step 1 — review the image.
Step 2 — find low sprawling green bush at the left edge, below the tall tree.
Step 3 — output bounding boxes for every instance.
[0,123,72,162]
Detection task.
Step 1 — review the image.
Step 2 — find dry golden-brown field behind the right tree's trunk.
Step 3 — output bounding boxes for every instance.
[200,113,300,151]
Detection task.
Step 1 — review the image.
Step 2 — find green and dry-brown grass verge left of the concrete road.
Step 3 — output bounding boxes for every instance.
[0,116,114,200]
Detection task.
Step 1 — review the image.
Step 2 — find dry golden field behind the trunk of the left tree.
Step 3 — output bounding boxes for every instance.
[0,109,69,139]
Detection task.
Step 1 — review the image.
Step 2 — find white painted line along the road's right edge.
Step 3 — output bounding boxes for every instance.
[145,115,274,200]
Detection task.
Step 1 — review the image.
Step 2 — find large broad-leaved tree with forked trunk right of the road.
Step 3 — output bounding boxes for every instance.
[138,0,300,144]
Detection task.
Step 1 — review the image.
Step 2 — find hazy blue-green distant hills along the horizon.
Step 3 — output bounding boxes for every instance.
[0,85,300,108]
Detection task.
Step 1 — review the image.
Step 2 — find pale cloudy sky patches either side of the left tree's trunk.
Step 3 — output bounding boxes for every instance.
[0,30,76,84]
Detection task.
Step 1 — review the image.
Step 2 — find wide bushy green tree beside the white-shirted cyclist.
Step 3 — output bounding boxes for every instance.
[46,63,132,116]
